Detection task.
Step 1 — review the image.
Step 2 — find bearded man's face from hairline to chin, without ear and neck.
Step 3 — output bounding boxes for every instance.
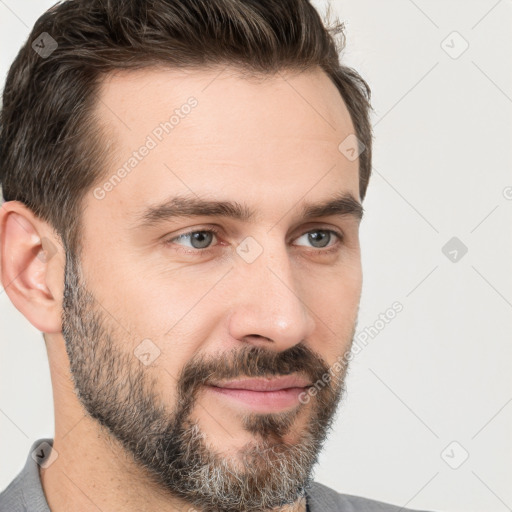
[63,69,362,511]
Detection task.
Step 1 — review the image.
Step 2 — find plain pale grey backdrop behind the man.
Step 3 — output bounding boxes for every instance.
[0,0,512,512]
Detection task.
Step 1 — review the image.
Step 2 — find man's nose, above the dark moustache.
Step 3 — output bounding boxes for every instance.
[229,245,315,351]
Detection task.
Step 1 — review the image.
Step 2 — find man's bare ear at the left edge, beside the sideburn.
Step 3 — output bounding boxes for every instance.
[0,201,65,333]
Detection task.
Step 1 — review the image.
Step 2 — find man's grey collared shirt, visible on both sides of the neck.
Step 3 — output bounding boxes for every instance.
[0,439,436,512]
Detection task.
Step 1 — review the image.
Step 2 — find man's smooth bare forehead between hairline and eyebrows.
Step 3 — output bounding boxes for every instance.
[87,64,359,222]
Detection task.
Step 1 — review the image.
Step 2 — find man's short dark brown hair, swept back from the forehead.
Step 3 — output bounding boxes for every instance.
[0,0,372,254]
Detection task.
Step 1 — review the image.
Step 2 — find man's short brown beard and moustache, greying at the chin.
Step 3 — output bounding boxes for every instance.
[62,254,355,512]
